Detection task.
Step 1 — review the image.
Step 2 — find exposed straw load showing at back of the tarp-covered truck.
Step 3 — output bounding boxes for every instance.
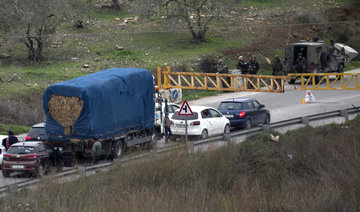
[48,94,84,135]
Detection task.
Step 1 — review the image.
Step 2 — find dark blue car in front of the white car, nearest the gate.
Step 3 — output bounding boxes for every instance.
[218,99,270,128]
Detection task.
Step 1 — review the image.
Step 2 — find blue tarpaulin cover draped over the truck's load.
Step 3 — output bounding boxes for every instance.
[43,68,154,139]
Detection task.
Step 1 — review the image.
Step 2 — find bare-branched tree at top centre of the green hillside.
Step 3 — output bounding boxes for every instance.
[164,0,219,42]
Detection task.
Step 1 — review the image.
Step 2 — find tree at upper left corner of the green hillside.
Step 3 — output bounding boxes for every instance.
[0,0,76,61]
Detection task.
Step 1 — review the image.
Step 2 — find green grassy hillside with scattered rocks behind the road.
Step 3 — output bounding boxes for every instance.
[0,0,360,126]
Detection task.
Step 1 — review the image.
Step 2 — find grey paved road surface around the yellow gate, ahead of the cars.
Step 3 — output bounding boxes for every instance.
[188,69,360,122]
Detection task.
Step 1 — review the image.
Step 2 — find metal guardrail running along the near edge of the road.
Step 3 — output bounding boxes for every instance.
[0,106,360,196]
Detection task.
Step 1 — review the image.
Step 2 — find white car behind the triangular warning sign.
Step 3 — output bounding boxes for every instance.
[171,106,230,139]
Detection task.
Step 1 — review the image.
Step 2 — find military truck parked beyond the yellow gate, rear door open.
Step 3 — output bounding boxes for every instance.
[284,38,358,83]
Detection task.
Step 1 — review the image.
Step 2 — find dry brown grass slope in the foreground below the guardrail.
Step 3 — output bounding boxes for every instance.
[0,116,360,211]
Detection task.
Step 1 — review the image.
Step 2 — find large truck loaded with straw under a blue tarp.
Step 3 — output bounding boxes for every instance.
[43,68,154,162]
